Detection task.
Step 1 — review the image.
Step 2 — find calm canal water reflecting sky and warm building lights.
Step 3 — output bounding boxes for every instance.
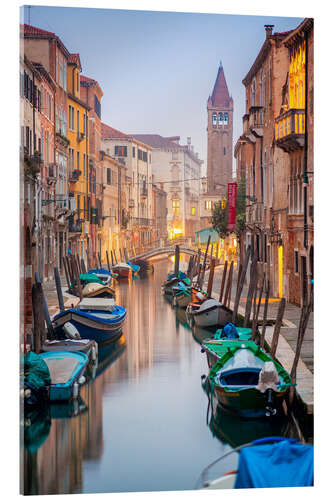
[24,260,289,494]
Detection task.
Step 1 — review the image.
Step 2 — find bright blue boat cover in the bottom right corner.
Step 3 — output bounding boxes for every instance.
[235,440,313,489]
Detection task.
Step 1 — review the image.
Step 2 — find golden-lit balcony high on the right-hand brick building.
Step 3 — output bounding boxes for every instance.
[275,109,305,153]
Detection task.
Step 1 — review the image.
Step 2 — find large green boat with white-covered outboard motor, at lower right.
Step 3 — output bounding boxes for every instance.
[207,340,292,418]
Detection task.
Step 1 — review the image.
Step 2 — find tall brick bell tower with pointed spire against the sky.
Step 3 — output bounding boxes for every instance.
[207,62,234,195]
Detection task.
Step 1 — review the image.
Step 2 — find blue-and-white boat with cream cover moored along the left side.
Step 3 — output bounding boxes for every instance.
[53,298,127,343]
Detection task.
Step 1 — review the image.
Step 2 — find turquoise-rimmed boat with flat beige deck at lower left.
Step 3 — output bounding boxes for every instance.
[38,351,89,401]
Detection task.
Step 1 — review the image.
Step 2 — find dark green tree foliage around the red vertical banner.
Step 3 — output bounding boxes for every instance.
[211,177,246,241]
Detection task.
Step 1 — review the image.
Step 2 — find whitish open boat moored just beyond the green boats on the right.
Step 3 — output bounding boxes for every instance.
[189,298,232,328]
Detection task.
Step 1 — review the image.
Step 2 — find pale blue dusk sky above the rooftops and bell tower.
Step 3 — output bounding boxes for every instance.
[20,6,303,174]
